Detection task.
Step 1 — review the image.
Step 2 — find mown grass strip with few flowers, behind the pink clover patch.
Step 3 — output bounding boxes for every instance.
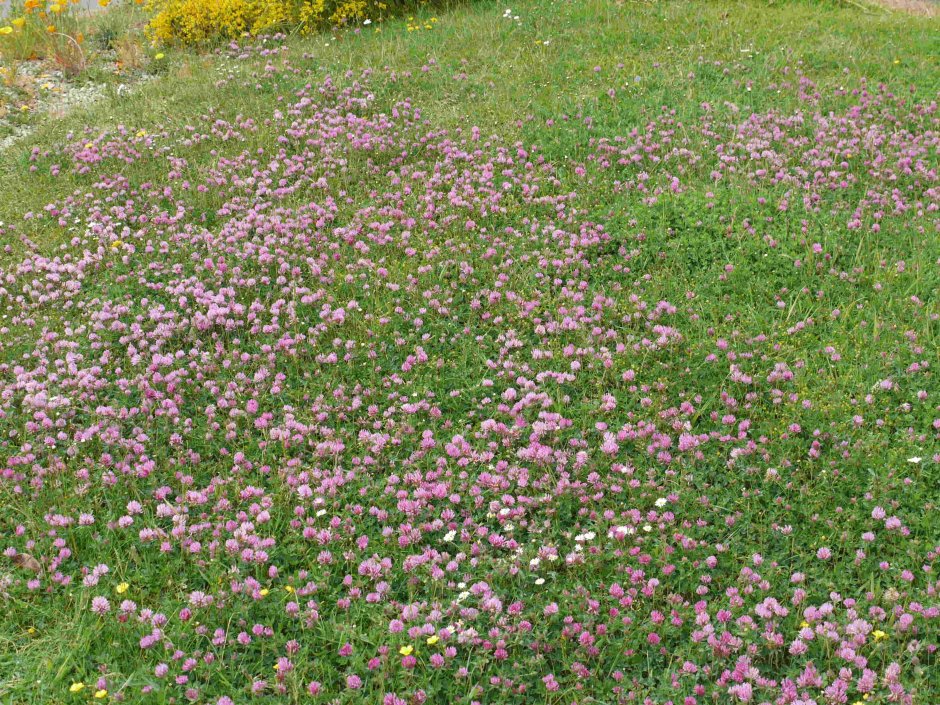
[0,0,938,250]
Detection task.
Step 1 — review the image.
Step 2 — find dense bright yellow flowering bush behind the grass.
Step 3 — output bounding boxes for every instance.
[149,0,390,44]
